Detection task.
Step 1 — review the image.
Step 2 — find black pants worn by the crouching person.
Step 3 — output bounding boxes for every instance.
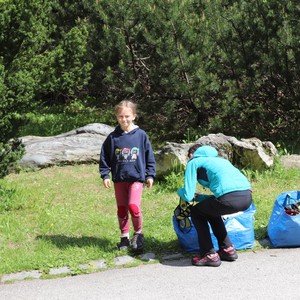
[191,190,252,256]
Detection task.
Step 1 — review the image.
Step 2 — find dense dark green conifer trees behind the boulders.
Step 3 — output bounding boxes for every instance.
[0,0,300,177]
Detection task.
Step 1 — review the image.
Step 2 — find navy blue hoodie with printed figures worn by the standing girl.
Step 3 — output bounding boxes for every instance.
[99,126,156,182]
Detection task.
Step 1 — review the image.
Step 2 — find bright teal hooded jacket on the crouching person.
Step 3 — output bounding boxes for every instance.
[177,146,251,202]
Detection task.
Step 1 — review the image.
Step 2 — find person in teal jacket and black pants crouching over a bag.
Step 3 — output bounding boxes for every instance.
[177,144,252,267]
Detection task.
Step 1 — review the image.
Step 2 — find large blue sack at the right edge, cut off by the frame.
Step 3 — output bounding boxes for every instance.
[268,191,300,247]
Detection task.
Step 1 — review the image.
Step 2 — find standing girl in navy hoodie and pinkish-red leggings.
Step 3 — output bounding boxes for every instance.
[99,100,156,252]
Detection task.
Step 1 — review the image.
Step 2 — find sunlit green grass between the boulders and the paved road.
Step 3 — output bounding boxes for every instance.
[0,164,300,275]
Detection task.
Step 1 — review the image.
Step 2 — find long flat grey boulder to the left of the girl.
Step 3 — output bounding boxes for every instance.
[20,123,114,169]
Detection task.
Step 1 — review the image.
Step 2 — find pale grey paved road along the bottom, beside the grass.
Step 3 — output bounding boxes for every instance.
[0,248,300,300]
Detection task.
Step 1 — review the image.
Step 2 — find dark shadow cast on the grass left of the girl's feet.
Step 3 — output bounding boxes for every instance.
[36,234,113,251]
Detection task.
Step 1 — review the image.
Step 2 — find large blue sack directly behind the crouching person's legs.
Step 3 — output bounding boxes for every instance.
[172,203,256,253]
